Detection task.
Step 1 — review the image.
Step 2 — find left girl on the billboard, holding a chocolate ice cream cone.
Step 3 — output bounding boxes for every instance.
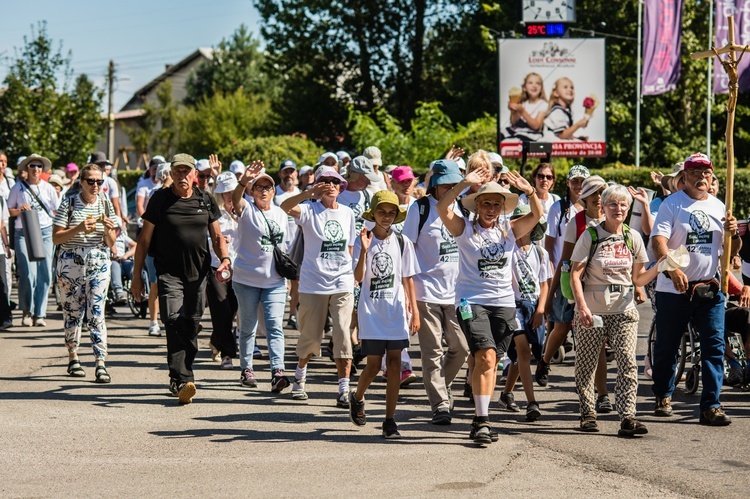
[506,73,549,142]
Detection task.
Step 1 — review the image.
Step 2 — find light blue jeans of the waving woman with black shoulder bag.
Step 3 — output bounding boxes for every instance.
[232,282,286,371]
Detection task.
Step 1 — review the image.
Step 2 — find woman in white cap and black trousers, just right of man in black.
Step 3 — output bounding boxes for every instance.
[206,172,238,369]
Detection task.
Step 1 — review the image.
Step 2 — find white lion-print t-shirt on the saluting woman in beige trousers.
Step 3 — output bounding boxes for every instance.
[297,202,356,295]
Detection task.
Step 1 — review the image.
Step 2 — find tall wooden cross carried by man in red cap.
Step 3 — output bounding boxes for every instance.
[690,16,750,294]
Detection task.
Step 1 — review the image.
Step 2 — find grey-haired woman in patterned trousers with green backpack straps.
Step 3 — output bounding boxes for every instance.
[570,184,657,437]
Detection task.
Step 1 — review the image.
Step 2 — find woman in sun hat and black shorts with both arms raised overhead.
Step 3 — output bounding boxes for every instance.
[436,151,542,445]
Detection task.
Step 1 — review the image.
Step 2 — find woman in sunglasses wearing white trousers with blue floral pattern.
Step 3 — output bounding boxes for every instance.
[52,163,115,383]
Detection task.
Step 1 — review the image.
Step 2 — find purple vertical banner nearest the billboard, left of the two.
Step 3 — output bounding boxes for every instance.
[641,0,682,95]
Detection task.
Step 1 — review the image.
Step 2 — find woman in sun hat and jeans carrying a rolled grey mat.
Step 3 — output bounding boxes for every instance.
[8,154,60,326]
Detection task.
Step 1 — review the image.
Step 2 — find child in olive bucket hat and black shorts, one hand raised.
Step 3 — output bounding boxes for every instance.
[349,191,419,439]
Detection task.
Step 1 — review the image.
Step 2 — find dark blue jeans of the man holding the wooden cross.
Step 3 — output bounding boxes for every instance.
[652,292,724,411]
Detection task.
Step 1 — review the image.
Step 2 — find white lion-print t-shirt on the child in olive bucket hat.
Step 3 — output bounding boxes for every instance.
[357,233,419,340]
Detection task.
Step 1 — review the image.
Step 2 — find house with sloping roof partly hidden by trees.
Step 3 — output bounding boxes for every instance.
[97,48,213,169]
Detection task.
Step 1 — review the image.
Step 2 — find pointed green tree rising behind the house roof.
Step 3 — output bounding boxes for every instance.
[184,24,275,106]
